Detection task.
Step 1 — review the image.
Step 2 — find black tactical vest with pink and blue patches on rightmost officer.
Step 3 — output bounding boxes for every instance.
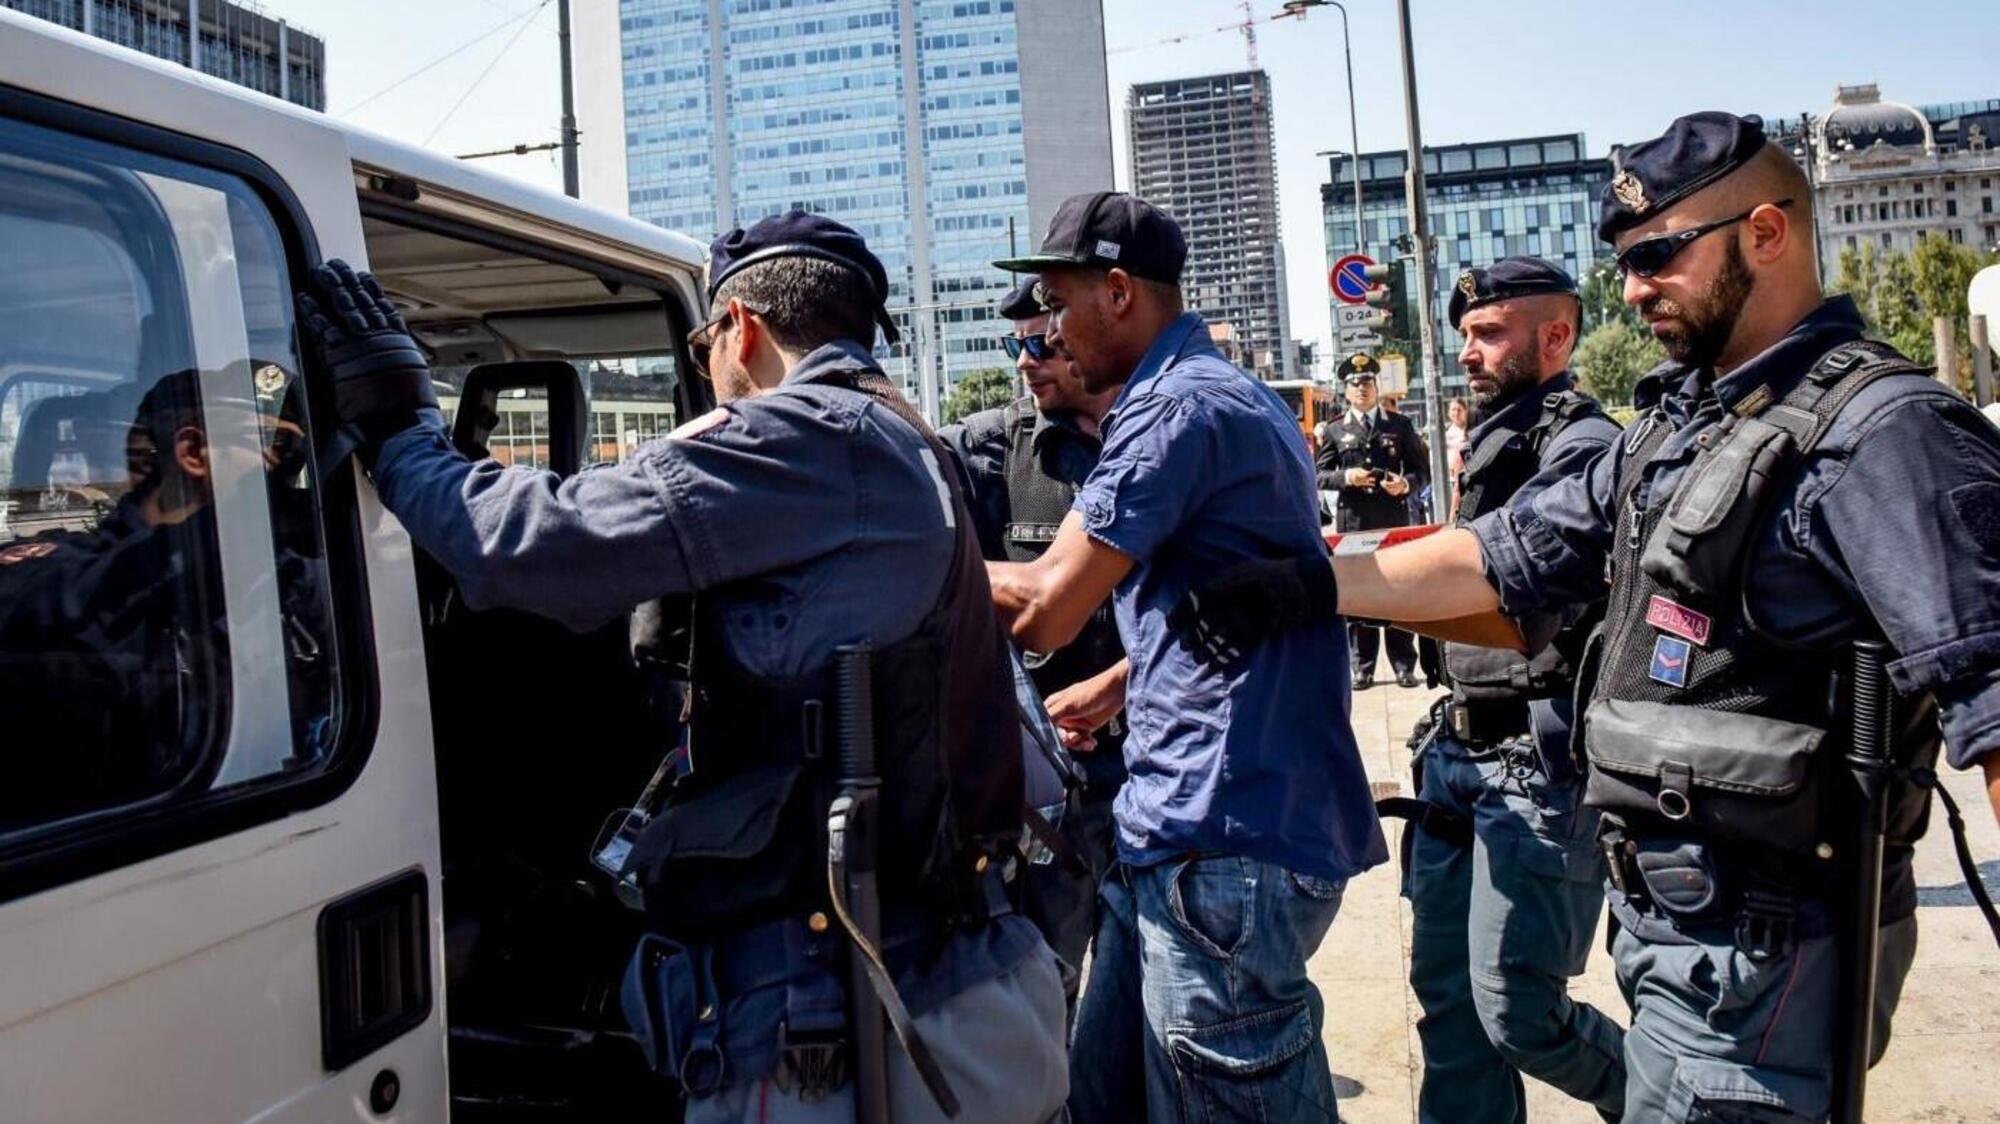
[1578,340,1938,856]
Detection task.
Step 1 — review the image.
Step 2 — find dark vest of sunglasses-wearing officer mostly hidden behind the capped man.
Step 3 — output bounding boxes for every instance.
[1002,398,1124,708]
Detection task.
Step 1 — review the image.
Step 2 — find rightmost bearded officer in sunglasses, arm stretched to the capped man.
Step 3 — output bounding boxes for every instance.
[1168,112,2000,1120]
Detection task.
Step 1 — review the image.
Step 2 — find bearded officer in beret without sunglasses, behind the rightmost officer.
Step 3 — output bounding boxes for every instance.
[1398,258,1624,1124]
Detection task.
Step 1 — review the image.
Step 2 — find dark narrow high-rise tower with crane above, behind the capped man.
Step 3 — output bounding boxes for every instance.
[1126,70,1290,378]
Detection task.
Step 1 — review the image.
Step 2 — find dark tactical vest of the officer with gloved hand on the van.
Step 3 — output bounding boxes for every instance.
[630,372,1024,940]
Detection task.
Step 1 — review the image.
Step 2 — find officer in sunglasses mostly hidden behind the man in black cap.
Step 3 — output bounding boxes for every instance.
[938,276,1126,1008]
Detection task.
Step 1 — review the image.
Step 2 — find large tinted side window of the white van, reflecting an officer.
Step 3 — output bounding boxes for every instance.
[0,120,340,844]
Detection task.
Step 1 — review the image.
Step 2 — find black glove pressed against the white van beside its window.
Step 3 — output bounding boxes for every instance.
[298,258,438,444]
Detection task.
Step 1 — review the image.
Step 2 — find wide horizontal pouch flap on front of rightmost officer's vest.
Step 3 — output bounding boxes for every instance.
[1584,698,1826,796]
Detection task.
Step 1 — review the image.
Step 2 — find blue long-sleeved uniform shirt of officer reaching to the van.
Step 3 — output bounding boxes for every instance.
[374,342,1040,1074]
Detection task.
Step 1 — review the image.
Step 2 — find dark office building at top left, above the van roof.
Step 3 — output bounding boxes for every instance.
[0,0,326,110]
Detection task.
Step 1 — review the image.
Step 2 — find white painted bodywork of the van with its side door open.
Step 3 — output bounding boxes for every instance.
[0,12,702,1124]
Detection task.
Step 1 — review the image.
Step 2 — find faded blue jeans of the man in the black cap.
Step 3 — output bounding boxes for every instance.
[1070,854,1346,1124]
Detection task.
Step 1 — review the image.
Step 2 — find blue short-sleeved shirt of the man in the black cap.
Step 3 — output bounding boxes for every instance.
[1076,314,1388,878]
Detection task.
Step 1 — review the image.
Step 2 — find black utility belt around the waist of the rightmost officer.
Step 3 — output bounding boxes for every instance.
[1598,816,1836,960]
